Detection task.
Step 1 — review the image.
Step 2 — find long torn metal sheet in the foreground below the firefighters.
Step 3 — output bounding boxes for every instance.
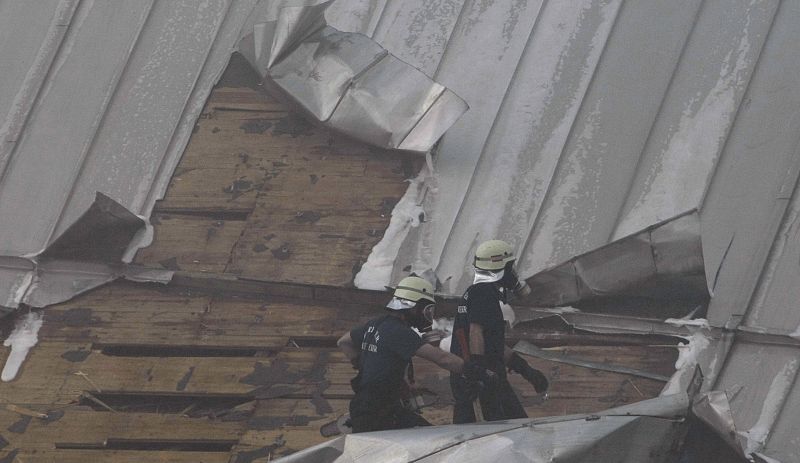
[277,393,689,463]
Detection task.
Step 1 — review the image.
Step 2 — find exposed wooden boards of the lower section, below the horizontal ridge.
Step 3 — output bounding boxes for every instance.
[0,282,675,462]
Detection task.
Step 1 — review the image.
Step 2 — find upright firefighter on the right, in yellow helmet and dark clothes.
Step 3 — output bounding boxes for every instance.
[450,240,548,424]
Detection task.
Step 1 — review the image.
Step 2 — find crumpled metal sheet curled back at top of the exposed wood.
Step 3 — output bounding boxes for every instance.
[234,0,468,153]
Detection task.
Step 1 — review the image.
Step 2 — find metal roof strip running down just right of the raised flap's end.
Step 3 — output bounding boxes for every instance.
[703,2,800,326]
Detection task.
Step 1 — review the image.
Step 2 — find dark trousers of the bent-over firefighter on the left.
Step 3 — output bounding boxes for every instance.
[350,392,431,433]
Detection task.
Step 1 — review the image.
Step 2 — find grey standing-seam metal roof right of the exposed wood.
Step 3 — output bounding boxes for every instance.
[329,0,800,461]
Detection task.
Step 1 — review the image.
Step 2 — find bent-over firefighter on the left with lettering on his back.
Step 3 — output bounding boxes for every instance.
[337,276,494,432]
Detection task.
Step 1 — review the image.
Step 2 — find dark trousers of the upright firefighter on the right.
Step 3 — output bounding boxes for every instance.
[450,367,528,424]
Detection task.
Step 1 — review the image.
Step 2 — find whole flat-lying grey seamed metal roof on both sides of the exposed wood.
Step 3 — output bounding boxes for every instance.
[0,0,800,461]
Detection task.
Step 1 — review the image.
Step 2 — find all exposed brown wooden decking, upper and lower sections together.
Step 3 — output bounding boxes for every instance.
[0,56,676,463]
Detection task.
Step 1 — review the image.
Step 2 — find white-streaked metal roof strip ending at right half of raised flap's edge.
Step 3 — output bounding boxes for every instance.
[614,0,777,238]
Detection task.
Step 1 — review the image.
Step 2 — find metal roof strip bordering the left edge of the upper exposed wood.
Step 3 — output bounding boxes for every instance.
[59,0,234,232]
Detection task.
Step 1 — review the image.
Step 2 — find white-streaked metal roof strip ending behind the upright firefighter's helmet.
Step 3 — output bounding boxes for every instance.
[438,0,621,286]
